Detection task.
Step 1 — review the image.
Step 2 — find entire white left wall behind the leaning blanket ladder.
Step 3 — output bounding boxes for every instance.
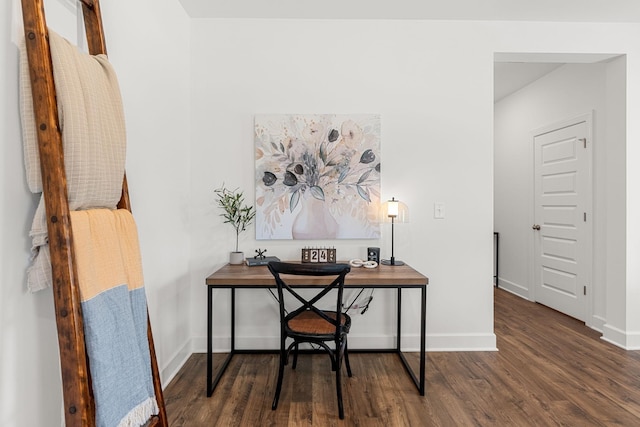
[0,0,191,427]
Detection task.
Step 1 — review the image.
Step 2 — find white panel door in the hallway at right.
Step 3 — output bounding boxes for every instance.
[533,121,591,321]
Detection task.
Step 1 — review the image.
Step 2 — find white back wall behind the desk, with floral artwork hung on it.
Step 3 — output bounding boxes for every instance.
[191,19,640,356]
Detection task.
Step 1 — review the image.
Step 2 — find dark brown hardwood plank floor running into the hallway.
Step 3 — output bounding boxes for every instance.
[164,290,640,427]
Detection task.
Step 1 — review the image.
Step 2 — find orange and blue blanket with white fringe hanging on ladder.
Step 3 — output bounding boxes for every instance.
[71,209,158,427]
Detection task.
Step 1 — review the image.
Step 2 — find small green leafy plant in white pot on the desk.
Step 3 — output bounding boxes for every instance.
[214,184,256,264]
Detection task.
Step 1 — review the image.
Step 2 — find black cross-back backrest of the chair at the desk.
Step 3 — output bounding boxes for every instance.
[268,261,351,335]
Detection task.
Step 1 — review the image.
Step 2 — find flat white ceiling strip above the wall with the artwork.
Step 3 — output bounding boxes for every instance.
[180,0,640,22]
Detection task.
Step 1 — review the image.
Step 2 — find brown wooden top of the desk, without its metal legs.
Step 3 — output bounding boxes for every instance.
[205,264,429,288]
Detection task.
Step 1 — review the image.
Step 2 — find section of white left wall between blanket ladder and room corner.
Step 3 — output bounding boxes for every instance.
[101,0,191,383]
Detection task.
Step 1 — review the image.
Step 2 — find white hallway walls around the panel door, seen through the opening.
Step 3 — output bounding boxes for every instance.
[494,57,626,331]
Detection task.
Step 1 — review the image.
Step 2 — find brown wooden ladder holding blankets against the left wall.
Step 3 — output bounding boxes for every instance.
[22,0,168,427]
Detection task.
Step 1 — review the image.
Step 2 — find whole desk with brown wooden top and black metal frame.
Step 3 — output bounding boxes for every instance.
[205,264,429,396]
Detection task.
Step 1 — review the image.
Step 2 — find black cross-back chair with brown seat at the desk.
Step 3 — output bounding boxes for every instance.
[269,261,352,419]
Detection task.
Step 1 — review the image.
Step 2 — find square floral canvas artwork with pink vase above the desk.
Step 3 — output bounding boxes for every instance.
[255,114,380,240]
